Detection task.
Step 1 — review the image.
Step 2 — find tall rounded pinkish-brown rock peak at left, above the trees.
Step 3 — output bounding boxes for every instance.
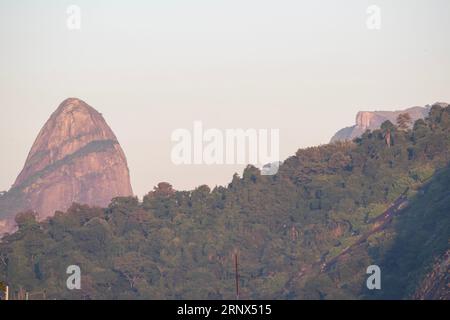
[3,98,133,219]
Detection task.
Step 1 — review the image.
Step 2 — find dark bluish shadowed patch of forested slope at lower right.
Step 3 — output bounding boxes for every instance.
[373,168,450,298]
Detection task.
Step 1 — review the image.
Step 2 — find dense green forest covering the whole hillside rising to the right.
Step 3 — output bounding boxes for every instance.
[0,106,450,299]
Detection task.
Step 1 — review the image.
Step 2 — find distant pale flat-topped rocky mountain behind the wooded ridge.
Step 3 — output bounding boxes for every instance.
[330,103,448,142]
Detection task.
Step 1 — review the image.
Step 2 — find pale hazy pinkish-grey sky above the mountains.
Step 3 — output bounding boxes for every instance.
[0,0,450,195]
